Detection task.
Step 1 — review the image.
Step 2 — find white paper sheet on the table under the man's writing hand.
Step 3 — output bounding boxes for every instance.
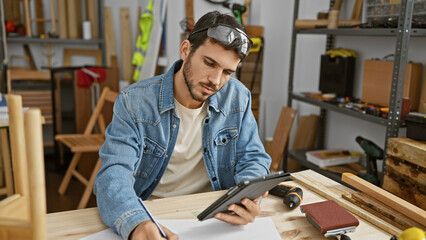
[80,218,281,240]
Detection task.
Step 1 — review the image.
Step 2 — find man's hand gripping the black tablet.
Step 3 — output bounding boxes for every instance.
[214,192,268,225]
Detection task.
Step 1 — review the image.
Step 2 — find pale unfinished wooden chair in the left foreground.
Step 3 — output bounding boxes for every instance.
[0,95,47,240]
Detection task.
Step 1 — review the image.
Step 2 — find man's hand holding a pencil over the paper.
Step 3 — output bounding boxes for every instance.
[131,220,179,240]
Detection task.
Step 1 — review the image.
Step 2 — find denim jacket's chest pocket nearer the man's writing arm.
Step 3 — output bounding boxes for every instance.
[135,137,166,178]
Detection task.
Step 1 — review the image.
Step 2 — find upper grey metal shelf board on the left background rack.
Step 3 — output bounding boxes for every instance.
[7,37,104,44]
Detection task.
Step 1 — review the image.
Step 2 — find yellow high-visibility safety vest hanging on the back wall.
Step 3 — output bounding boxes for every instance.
[132,0,154,82]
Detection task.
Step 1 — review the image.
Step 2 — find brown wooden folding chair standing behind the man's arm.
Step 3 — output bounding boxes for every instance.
[55,87,118,209]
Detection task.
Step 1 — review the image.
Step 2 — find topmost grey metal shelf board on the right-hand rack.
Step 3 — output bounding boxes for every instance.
[296,28,426,37]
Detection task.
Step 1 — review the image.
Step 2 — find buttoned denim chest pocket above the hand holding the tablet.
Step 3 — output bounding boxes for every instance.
[214,127,238,171]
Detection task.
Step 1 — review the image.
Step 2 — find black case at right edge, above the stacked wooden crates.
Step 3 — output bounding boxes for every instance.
[405,112,426,141]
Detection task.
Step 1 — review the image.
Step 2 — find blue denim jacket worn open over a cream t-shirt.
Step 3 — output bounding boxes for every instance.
[94,60,271,239]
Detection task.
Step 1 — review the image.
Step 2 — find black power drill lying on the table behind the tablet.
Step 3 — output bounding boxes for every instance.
[269,183,303,209]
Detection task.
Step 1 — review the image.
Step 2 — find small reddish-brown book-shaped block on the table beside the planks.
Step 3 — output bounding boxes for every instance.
[300,200,359,237]
